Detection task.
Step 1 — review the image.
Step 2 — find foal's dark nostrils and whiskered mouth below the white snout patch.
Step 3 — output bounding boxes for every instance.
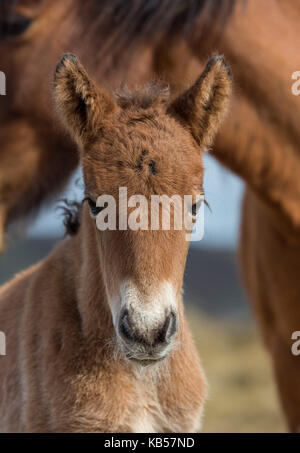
[118,309,177,365]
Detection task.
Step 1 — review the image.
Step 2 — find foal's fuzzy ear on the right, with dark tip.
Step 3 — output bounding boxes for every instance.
[169,55,232,147]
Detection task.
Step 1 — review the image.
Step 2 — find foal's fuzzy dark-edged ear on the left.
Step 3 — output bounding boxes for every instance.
[54,54,117,145]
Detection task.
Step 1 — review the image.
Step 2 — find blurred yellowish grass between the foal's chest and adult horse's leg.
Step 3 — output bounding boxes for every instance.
[187,310,286,433]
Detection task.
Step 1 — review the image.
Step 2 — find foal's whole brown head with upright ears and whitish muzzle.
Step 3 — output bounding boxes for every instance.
[55,54,231,364]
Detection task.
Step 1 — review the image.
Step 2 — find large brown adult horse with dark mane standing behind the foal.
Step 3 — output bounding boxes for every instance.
[0,0,300,430]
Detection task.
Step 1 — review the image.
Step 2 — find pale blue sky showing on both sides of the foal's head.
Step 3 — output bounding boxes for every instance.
[28,155,243,249]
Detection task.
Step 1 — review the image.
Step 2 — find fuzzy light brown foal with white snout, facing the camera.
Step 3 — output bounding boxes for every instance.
[0,54,231,432]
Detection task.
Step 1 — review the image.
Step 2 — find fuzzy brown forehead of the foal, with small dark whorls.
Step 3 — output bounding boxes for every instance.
[83,110,203,195]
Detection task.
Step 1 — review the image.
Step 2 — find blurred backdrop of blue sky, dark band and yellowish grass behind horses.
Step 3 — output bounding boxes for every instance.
[0,152,286,432]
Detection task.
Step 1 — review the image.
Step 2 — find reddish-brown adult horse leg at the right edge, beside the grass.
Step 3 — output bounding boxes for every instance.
[240,189,300,431]
